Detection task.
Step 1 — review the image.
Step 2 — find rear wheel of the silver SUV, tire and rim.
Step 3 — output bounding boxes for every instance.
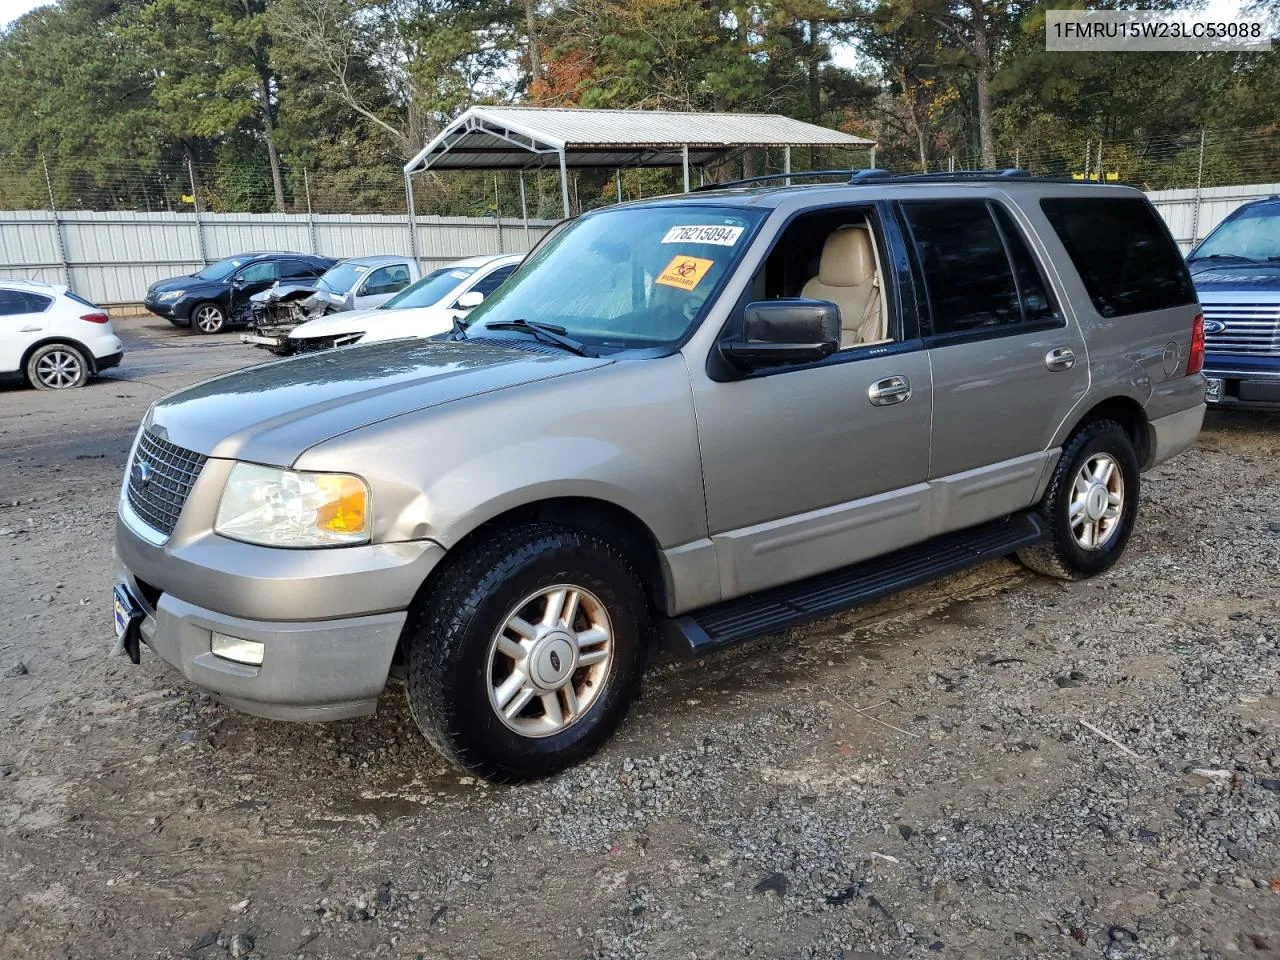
[1018,420,1142,580]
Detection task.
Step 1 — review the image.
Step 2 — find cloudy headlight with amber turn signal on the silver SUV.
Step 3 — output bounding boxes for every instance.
[214,463,372,547]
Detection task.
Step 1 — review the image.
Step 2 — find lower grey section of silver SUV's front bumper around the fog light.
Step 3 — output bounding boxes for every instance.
[120,571,406,721]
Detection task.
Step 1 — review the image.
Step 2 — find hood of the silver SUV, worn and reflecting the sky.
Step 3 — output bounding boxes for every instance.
[148,340,612,466]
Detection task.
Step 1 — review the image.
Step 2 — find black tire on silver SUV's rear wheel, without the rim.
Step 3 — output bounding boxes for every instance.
[1018,420,1142,580]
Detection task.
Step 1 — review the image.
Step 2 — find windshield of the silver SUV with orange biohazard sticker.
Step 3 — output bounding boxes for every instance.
[467,204,765,351]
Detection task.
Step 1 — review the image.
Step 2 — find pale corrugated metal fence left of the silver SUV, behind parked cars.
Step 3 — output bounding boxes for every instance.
[0,210,554,303]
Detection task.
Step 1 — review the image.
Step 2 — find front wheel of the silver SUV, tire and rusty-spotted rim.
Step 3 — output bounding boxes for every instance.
[406,524,649,782]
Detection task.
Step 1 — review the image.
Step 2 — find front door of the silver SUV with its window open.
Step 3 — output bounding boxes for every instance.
[692,206,933,599]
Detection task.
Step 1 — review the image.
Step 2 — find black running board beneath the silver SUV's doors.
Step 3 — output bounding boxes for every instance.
[664,513,1044,657]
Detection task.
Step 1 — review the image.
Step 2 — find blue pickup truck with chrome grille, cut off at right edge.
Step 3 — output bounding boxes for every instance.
[1187,196,1280,410]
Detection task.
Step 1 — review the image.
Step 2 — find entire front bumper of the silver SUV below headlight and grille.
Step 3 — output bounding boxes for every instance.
[115,500,444,721]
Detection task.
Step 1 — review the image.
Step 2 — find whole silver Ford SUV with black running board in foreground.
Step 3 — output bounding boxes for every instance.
[114,172,1204,781]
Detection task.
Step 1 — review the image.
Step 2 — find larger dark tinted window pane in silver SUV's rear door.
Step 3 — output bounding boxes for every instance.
[902,200,1023,334]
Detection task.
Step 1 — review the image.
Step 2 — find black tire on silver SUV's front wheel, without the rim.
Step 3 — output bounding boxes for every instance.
[406,522,650,783]
